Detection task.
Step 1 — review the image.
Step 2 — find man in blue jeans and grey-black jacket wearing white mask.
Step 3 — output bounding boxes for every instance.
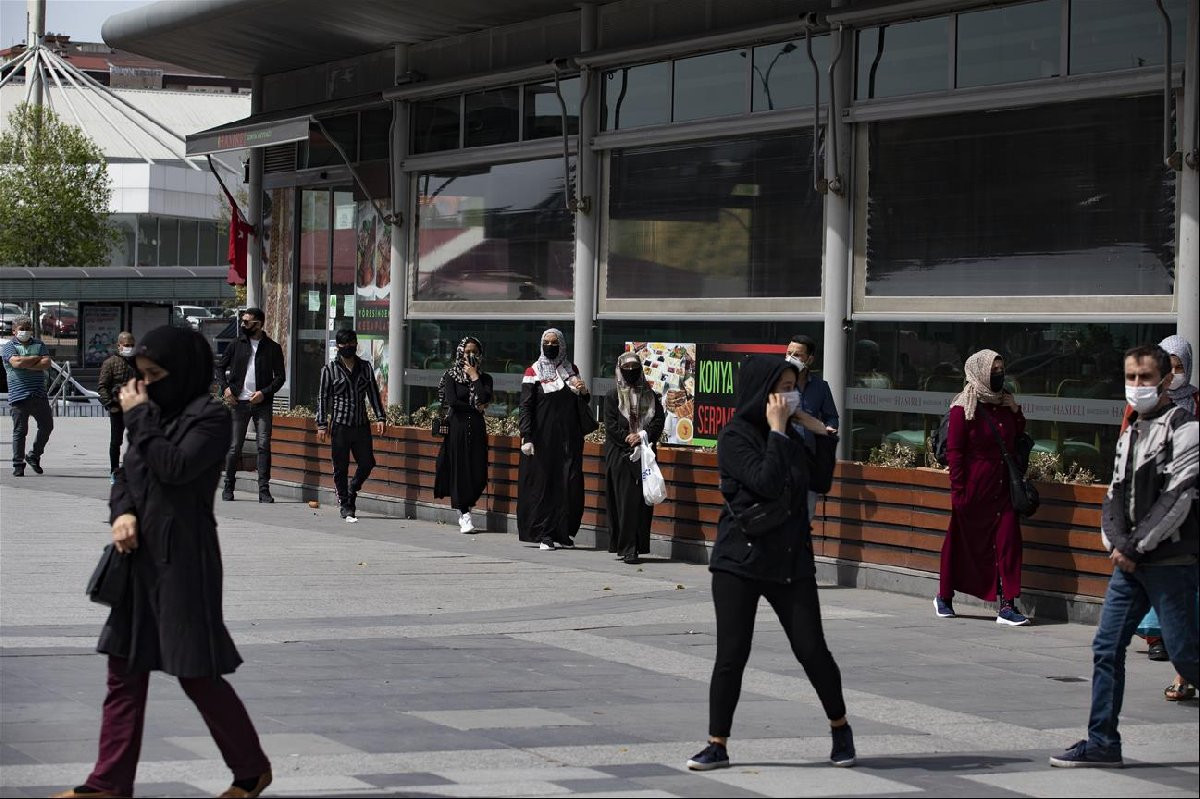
[1050,344,1200,768]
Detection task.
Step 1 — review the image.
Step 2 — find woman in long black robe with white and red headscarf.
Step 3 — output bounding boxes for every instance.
[517,328,594,549]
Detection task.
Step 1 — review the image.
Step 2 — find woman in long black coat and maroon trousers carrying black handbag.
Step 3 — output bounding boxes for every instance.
[59,328,271,798]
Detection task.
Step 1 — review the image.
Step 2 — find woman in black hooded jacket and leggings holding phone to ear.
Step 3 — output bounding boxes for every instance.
[688,355,856,771]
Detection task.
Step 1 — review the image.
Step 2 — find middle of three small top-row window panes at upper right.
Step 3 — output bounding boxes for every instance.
[956,0,1062,86]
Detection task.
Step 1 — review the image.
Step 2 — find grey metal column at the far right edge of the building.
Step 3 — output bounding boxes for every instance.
[1175,0,1200,347]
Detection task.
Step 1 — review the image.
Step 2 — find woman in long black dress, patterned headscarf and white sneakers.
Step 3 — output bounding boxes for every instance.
[433,336,492,533]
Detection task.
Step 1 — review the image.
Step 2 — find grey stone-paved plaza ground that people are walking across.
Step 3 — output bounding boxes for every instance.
[0,419,1200,797]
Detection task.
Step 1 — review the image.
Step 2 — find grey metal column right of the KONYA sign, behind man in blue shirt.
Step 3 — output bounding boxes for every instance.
[821,23,854,457]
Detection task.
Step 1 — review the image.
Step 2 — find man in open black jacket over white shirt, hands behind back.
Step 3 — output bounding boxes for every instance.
[214,308,284,503]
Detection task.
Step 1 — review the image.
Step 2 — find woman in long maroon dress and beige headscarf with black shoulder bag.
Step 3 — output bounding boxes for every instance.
[934,349,1030,627]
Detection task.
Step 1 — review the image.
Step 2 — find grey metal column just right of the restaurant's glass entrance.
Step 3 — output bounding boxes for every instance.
[393,44,414,410]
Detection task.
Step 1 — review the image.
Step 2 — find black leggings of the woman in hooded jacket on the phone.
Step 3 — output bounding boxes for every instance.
[708,571,846,738]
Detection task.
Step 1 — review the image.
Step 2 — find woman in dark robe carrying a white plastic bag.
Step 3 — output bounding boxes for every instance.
[604,353,666,564]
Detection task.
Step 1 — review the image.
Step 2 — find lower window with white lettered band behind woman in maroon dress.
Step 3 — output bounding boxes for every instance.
[842,322,1175,480]
